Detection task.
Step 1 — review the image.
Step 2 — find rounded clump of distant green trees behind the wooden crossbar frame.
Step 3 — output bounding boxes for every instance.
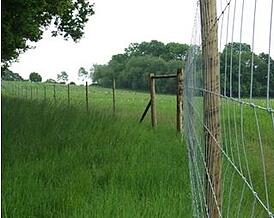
[93,40,189,93]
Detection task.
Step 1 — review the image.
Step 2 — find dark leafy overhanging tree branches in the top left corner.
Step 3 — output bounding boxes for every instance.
[1,0,94,63]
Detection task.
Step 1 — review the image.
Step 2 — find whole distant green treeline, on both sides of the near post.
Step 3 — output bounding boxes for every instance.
[92,40,274,97]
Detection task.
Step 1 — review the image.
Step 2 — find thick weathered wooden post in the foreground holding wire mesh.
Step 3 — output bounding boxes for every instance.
[200,0,221,218]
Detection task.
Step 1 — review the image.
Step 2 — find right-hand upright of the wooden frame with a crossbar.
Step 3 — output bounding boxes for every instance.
[177,69,183,133]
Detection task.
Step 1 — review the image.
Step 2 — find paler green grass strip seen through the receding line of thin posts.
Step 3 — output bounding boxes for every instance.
[2,81,180,128]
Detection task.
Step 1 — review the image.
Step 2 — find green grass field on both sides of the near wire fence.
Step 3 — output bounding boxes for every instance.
[1,82,274,217]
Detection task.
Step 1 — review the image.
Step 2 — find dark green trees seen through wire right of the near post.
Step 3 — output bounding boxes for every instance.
[220,42,274,97]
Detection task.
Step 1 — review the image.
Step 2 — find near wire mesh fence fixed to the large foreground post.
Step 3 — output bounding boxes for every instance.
[184,0,274,217]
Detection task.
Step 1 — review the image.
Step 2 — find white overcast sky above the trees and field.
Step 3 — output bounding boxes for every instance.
[11,0,274,81]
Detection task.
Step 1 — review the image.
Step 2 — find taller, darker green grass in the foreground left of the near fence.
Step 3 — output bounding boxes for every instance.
[2,97,191,217]
